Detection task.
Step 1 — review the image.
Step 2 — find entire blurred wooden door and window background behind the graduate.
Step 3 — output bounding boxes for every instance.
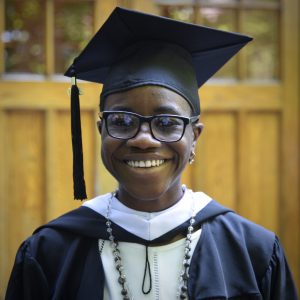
[0,0,300,299]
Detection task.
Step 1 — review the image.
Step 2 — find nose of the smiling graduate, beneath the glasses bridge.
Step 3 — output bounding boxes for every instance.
[126,123,161,149]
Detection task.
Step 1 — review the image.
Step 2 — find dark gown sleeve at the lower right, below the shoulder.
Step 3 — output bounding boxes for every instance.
[262,237,298,300]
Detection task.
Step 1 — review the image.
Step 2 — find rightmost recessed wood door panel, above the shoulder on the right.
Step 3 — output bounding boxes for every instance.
[238,113,280,233]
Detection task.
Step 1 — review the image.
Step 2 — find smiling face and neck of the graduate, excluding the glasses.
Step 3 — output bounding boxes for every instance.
[98,86,202,211]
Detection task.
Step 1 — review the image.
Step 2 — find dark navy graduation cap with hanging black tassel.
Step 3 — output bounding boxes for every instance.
[65,7,252,199]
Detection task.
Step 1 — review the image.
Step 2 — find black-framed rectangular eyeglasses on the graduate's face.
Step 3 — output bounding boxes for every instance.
[100,111,199,143]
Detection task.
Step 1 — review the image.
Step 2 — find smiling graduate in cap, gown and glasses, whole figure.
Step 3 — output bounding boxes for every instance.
[6,8,297,300]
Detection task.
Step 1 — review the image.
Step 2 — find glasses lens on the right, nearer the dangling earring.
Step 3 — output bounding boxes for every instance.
[151,116,184,142]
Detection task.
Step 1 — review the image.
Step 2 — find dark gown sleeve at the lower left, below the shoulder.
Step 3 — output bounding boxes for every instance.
[5,240,49,300]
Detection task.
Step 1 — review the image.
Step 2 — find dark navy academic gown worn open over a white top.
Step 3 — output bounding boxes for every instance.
[5,201,297,300]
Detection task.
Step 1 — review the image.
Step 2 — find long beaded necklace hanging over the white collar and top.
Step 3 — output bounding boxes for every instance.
[106,192,195,300]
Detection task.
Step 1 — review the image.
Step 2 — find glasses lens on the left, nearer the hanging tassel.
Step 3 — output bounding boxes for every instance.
[106,113,139,139]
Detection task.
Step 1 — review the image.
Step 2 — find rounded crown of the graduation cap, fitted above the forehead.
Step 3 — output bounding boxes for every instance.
[100,41,200,115]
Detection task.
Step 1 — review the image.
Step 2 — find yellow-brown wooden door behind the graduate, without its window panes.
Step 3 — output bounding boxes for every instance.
[0,0,300,299]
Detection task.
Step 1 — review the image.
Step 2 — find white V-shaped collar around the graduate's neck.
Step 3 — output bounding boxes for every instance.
[83,188,211,241]
